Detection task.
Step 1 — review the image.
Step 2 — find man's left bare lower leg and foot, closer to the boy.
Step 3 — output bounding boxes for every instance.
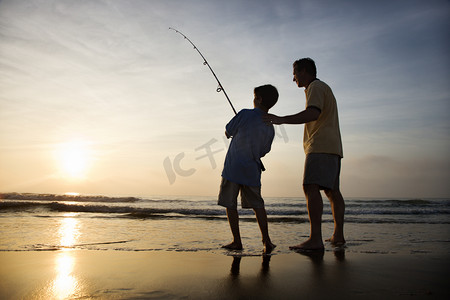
[289,184,324,250]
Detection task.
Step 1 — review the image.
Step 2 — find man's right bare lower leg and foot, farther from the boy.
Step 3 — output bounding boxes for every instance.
[325,188,345,246]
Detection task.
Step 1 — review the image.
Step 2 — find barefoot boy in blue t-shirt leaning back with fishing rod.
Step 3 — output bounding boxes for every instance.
[218,85,278,253]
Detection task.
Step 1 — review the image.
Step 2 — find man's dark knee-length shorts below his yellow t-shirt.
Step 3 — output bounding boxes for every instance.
[303,153,341,190]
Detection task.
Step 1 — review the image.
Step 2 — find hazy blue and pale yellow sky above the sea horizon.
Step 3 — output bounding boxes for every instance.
[0,0,450,198]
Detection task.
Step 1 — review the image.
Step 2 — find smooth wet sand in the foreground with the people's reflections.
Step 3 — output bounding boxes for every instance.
[0,250,450,299]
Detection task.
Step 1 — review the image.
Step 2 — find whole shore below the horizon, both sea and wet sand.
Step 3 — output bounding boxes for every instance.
[0,194,450,299]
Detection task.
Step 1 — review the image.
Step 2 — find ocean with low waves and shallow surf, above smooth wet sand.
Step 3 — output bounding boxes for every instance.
[0,193,450,256]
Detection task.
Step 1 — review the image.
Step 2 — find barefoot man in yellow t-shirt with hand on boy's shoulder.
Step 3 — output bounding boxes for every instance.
[264,58,345,251]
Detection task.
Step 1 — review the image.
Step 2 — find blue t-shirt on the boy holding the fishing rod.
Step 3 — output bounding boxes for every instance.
[222,108,275,186]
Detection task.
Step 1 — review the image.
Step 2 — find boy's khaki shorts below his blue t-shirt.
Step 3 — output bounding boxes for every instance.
[218,177,264,209]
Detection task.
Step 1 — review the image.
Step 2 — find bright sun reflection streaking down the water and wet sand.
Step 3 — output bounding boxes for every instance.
[50,213,82,299]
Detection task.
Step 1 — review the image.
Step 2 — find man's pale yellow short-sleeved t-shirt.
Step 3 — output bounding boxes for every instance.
[303,79,343,157]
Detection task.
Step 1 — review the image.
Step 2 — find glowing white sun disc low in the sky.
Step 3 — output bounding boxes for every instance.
[57,140,92,180]
